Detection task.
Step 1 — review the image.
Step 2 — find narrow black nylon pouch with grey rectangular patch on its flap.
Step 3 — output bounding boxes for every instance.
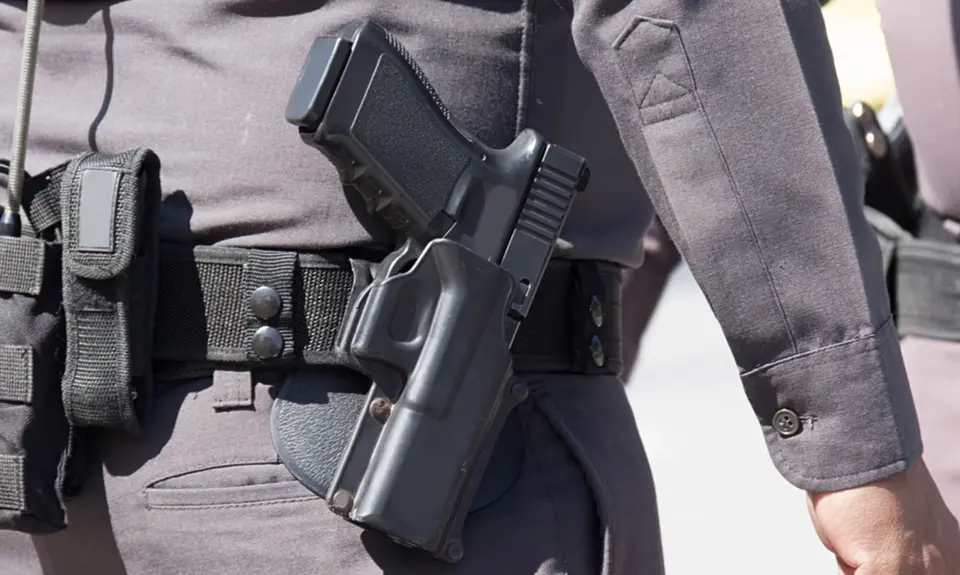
[60,149,160,433]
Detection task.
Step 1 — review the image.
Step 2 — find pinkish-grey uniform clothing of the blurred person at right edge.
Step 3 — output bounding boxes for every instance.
[877,0,960,516]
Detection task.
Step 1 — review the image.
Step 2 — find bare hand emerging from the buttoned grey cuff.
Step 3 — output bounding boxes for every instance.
[807,459,960,575]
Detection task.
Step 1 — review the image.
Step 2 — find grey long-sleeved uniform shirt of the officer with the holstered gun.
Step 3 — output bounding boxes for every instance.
[0,0,921,496]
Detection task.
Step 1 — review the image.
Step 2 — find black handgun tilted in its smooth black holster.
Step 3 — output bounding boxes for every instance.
[286,22,589,562]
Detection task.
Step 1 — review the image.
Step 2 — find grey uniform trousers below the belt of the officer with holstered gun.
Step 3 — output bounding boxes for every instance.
[0,376,662,575]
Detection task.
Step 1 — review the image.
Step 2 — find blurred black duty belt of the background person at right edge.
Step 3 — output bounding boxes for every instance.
[867,208,960,341]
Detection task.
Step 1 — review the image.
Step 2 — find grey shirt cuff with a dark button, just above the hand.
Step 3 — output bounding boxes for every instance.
[742,319,923,492]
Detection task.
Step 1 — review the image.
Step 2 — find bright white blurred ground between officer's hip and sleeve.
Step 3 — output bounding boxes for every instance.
[627,267,836,575]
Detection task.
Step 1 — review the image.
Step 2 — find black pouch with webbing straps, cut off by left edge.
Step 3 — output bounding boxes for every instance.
[0,237,72,534]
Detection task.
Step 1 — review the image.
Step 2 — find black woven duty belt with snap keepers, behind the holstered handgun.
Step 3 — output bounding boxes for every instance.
[154,244,621,374]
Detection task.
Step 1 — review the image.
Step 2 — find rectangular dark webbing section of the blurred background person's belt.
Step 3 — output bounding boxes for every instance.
[896,240,960,341]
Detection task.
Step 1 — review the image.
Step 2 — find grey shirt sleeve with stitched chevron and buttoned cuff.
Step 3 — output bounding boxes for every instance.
[572,0,922,491]
